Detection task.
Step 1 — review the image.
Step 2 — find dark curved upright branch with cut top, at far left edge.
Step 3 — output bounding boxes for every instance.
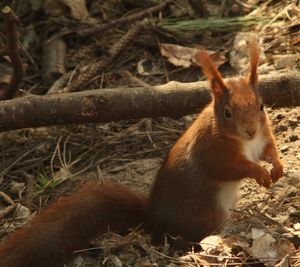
[0,6,24,100]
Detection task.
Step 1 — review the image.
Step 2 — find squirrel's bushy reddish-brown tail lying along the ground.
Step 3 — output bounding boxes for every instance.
[0,183,147,267]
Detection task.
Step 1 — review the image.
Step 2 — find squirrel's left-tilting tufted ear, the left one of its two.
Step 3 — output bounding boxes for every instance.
[199,50,227,98]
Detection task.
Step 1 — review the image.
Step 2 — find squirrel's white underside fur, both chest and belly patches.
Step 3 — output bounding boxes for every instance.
[218,130,267,218]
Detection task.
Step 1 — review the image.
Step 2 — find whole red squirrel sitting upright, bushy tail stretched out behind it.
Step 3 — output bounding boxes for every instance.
[0,38,283,267]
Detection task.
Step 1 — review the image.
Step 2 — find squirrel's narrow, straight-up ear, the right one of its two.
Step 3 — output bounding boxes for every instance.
[248,37,260,88]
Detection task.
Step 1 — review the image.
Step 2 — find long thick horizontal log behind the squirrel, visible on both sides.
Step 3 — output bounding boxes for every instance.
[0,72,300,131]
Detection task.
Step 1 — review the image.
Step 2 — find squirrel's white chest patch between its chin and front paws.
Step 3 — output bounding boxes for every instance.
[243,133,267,162]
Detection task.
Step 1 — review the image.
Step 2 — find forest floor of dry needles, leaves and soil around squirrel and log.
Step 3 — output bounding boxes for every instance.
[0,0,300,267]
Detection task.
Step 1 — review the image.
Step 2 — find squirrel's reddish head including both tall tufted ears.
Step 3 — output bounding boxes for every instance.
[199,39,266,140]
